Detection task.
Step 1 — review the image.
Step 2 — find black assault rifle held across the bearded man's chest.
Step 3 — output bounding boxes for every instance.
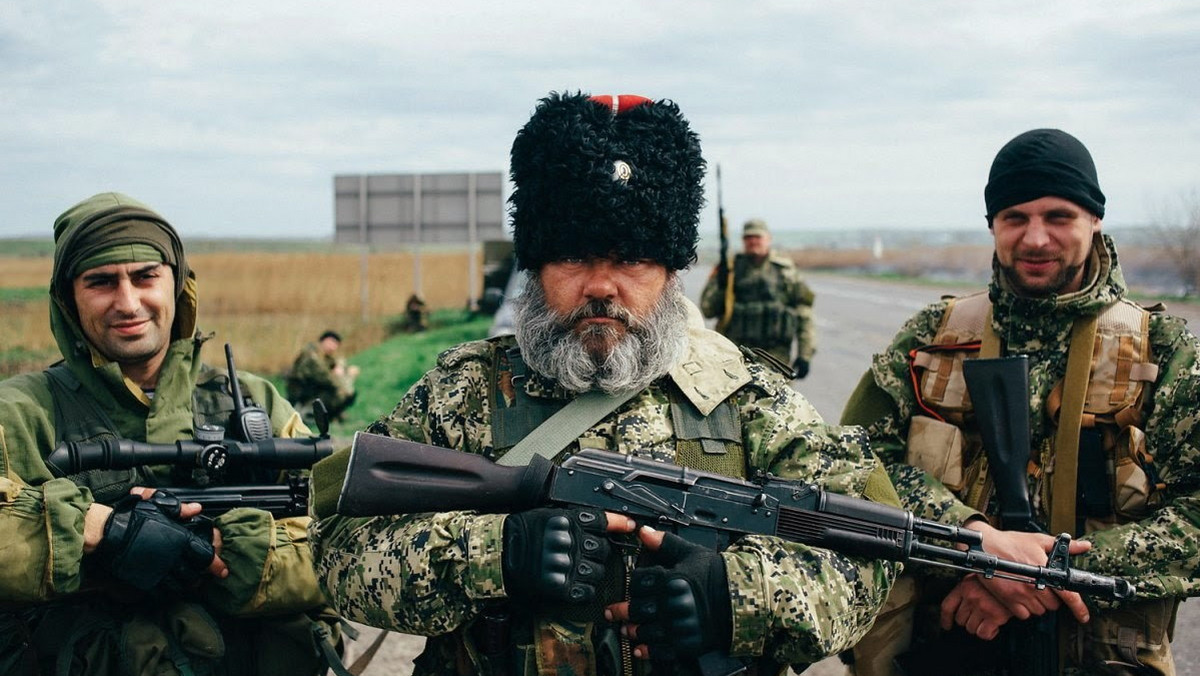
[337,432,1134,599]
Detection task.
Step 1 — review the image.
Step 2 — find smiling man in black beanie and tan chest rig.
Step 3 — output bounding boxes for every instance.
[842,128,1200,676]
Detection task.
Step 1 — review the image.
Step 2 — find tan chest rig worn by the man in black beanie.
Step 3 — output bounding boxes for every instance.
[908,292,1165,534]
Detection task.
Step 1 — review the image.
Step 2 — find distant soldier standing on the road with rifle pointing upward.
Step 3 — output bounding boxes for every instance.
[700,219,817,378]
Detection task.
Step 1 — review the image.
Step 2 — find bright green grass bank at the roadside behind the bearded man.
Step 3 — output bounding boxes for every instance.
[272,310,492,443]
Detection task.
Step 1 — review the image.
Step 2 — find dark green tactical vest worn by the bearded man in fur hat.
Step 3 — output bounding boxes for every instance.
[468,347,748,676]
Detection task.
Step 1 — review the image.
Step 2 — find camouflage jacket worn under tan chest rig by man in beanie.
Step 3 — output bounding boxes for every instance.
[842,235,1200,603]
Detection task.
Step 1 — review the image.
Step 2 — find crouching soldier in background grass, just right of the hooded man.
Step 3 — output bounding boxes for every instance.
[287,331,359,420]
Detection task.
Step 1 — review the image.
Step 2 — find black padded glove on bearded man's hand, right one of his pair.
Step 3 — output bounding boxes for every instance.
[629,533,733,660]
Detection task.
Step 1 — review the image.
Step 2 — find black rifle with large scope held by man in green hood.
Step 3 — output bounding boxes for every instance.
[46,345,334,518]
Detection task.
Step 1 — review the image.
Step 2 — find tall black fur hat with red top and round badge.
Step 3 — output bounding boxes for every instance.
[509,92,704,270]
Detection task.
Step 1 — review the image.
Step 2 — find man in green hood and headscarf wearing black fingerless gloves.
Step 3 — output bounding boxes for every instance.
[0,193,336,676]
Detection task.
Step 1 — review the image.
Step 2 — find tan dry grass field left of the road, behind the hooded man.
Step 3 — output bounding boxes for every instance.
[0,251,480,377]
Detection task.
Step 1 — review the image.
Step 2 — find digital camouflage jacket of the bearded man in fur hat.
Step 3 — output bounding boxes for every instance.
[310,328,896,676]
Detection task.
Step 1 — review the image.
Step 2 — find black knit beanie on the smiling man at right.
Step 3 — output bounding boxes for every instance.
[983,130,1104,227]
